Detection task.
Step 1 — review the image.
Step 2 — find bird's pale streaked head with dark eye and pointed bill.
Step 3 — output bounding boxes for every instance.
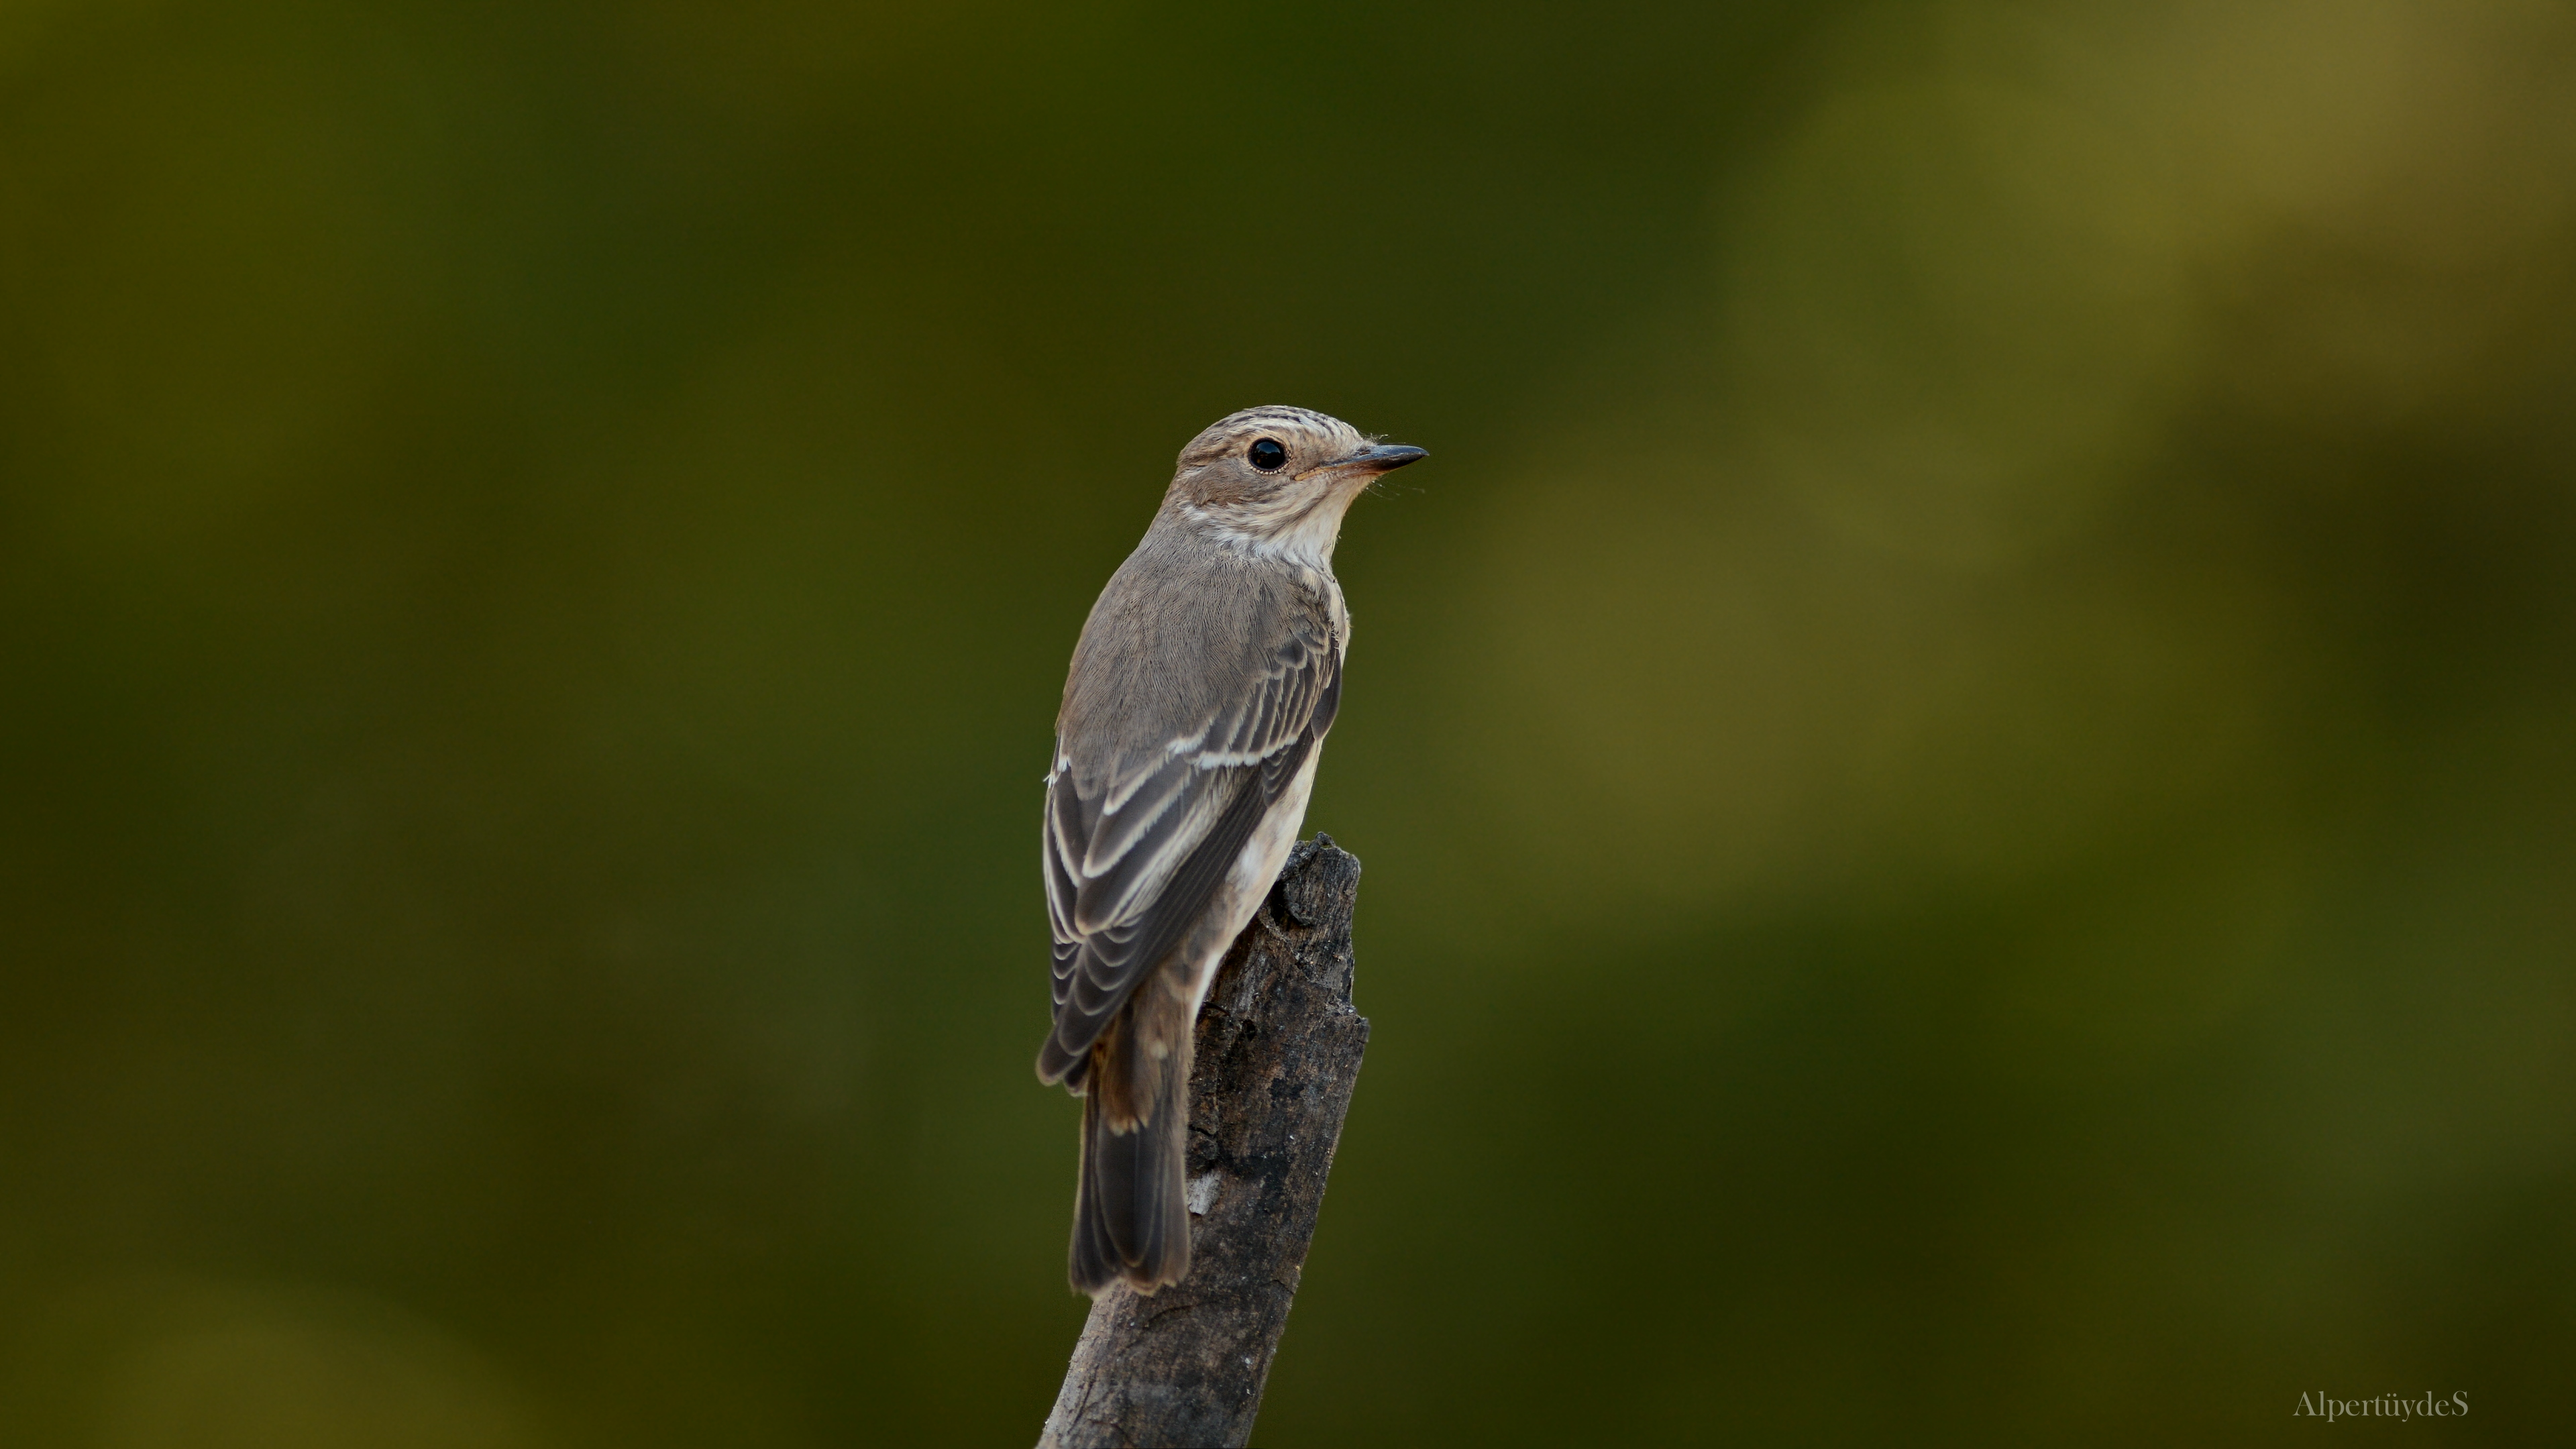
[1165,407,1427,559]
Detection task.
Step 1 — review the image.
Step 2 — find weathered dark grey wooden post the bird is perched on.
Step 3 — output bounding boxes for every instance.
[1038,833,1368,1449]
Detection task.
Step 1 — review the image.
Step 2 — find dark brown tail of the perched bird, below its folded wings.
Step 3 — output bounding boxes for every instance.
[1071,1005,1190,1297]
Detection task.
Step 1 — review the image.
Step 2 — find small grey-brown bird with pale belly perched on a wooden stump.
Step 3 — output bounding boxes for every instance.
[1038,407,1425,1294]
